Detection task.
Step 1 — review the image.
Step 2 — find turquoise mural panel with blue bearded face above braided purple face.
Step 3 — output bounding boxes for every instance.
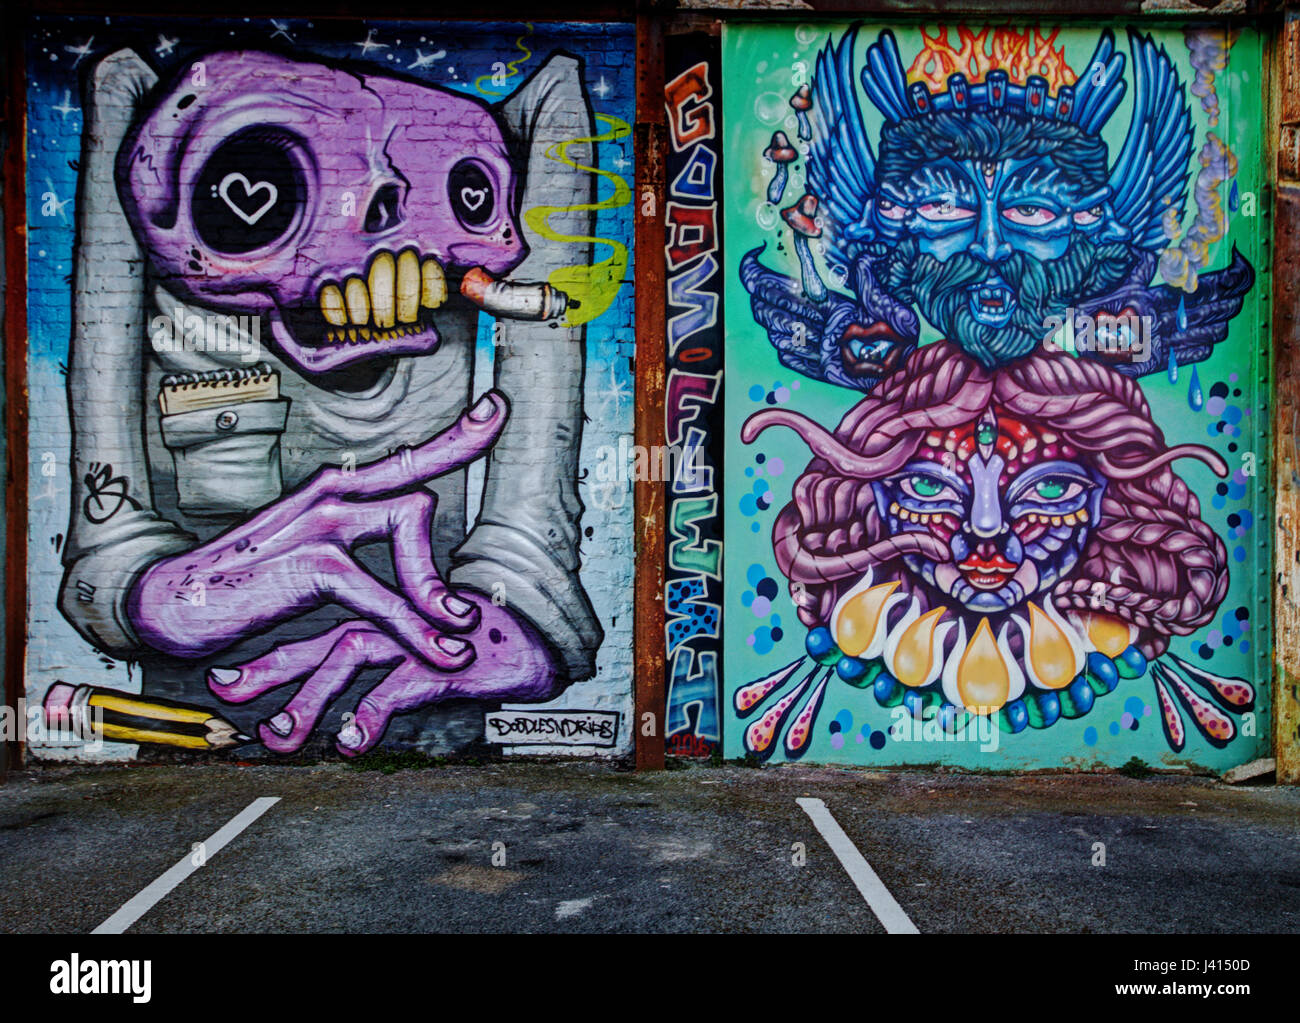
[723,23,1270,770]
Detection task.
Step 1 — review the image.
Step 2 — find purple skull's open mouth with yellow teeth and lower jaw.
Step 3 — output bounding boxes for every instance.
[270,248,449,373]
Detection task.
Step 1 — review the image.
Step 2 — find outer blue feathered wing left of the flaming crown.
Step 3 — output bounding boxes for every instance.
[807,26,875,266]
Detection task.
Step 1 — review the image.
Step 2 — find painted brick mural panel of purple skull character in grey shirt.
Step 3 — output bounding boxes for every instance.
[26,18,634,759]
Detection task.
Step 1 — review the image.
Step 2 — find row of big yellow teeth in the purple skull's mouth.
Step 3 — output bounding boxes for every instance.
[317,248,447,344]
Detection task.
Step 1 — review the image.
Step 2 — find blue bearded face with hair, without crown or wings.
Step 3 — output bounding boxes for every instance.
[865,112,1138,365]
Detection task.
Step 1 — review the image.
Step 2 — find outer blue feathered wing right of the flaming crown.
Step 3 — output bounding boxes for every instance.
[1110,30,1192,250]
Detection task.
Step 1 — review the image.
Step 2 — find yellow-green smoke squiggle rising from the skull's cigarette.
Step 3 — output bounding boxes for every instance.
[524,113,632,326]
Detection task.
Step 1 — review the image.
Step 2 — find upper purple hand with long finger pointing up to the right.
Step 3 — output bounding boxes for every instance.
[127,391,510,671]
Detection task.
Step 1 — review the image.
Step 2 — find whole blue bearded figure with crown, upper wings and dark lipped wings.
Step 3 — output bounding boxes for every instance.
[740,26,1253,391]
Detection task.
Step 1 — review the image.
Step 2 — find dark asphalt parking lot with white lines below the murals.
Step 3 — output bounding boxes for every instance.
[0,762,1300,933]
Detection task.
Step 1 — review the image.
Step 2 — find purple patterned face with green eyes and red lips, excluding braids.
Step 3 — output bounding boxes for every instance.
[872,409,1105,614]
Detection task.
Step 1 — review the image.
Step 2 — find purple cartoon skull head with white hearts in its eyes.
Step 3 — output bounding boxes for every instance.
[118,52,528,373]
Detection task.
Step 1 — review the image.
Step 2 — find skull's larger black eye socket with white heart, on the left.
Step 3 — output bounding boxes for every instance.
[191,129,307,255]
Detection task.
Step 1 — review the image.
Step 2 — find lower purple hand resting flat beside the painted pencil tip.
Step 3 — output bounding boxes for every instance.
[208,599,559,757]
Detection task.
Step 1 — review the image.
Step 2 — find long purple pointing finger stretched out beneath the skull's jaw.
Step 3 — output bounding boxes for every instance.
[308,390,510,498]
